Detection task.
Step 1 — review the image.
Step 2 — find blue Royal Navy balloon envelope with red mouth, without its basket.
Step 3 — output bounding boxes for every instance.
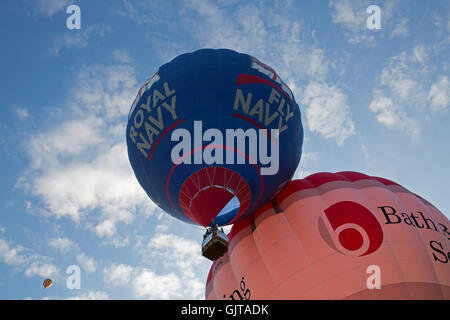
[126,49,303,226]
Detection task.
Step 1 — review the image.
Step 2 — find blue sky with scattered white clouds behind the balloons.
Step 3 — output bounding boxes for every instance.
[0,0,450,299]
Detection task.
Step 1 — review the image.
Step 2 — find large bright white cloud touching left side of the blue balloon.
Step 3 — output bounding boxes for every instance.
[29,143,147,228]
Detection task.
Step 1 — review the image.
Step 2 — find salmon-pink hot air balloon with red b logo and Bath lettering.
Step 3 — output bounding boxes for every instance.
[206,172,450,300]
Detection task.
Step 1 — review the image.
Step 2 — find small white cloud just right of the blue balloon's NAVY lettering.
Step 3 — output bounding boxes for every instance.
[301,82,355,146]
